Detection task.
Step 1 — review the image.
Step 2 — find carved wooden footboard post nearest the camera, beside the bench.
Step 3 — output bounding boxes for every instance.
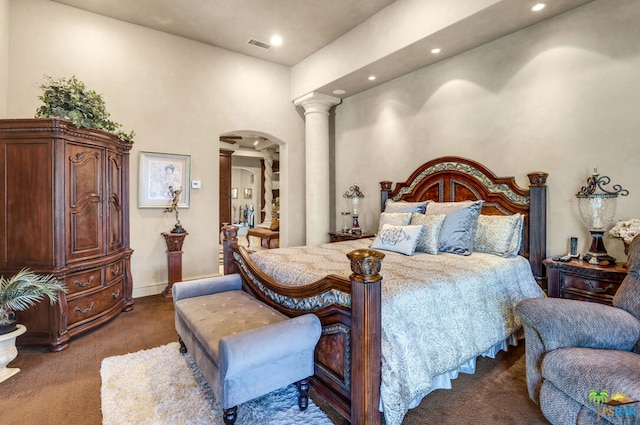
[347,249,384,425]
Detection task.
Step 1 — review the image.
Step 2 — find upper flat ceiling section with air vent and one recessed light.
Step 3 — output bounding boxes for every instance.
[53,0,394,66]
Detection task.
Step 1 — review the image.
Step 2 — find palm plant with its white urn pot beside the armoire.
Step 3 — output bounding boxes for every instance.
[0,269,67,382]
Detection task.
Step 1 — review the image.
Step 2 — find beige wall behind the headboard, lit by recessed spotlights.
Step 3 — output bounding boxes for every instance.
[335,0,640,260]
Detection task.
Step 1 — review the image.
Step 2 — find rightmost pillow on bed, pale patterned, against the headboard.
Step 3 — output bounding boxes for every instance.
[473,214,524,257]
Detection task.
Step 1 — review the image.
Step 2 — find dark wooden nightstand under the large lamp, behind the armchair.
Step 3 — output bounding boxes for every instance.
[543,258,628,305]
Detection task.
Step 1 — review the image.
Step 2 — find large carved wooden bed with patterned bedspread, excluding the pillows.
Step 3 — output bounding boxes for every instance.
[223,157,547,424]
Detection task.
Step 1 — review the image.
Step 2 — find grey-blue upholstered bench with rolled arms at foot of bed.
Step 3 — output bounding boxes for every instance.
[172,274,321,424]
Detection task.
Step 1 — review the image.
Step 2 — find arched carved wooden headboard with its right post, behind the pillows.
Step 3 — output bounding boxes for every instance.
[380,156,548,287]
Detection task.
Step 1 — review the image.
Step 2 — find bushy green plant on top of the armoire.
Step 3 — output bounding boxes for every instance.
[35,75,135,142]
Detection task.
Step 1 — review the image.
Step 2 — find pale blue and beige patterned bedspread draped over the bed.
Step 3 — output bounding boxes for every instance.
[252,239,544,425]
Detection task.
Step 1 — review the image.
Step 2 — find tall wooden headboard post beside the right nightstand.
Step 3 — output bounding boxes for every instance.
[527,171,549,290]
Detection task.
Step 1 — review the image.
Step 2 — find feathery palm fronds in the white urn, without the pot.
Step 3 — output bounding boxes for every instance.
[0,269,67,335]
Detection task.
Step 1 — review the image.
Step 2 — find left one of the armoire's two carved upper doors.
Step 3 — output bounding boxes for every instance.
[65,143,104,261]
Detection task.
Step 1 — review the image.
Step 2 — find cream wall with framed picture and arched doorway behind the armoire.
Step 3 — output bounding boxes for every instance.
[5,0,304,296]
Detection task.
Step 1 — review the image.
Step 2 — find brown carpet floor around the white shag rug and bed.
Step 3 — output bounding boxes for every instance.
[0,295,548,425]
